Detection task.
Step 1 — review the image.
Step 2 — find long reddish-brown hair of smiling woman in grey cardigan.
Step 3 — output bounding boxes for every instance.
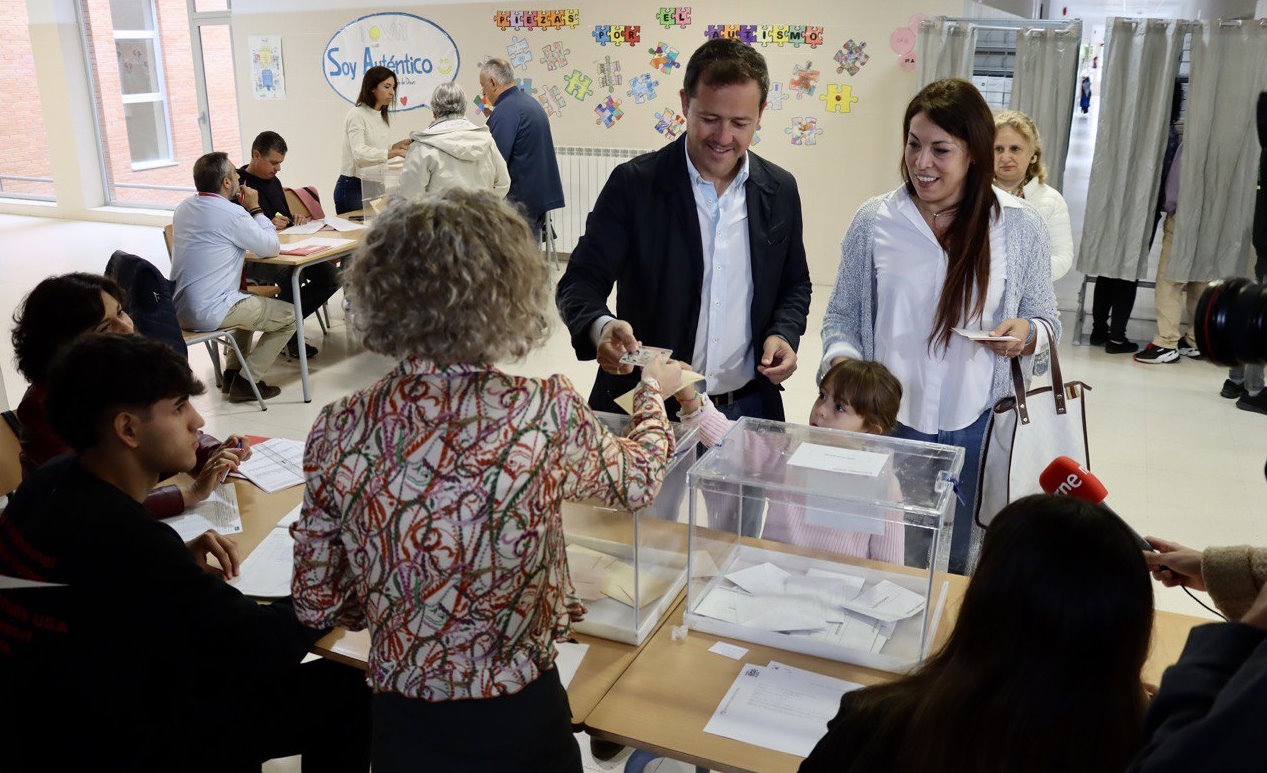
[902,77,998,351]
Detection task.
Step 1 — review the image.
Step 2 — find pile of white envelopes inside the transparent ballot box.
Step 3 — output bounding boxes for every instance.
[693,563,924,653]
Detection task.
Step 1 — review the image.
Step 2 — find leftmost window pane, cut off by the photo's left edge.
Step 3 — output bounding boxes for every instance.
[0,0,54,200]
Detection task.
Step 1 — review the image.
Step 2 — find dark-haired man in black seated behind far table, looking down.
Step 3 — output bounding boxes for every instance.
[238,132,340,357]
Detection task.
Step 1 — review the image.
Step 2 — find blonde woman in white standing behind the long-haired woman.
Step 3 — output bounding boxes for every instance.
[995,110,1073,281]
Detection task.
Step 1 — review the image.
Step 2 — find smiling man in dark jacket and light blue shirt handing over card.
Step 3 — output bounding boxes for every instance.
[554,39,811,421]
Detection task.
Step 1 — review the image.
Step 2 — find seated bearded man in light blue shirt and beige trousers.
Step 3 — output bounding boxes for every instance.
[171,153,295,403]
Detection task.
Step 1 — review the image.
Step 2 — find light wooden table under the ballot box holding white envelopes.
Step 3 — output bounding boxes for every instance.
[585,587,1210,773]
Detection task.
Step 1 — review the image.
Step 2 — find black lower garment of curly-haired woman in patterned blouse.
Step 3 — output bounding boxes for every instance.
[374,669,582,773]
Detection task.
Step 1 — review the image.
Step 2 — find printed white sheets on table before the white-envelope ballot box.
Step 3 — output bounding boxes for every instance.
[704,660,862,757]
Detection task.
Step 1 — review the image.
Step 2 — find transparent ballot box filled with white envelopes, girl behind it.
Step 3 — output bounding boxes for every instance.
[685,418,963,670]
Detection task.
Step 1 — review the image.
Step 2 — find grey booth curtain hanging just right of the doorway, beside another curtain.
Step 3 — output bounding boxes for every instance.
[1077,19,1187,281]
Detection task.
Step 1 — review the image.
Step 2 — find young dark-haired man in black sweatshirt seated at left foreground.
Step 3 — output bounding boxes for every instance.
[0,333,370,773]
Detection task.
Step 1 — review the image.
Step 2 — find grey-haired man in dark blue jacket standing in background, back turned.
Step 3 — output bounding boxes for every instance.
[479,60,563,233]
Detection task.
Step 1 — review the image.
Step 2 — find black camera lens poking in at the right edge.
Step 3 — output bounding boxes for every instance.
[1192,279,1267,366]
